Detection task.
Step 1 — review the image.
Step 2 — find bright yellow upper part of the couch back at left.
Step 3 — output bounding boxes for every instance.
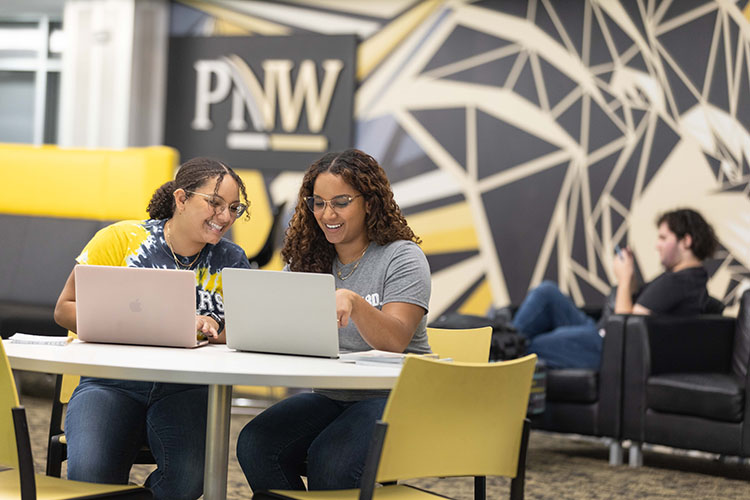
[0,144,178,220]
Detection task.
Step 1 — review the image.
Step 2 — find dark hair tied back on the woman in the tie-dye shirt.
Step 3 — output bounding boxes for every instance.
[146,157,250,219]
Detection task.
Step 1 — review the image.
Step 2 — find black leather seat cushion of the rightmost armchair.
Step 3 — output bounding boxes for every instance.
[646,373,745,422]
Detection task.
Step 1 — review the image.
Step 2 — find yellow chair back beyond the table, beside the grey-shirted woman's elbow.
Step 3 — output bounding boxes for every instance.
[427,326,492,363]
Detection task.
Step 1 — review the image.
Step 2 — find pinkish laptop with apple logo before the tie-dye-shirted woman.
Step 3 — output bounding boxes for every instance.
[75,265,207,347]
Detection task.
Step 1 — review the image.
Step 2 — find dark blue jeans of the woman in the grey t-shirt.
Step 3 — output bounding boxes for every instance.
[237,393,386,491]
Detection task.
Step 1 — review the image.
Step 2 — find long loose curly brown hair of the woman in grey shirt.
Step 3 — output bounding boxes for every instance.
[281,149,422,273]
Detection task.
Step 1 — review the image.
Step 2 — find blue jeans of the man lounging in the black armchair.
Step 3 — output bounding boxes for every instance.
[513,281,602,370]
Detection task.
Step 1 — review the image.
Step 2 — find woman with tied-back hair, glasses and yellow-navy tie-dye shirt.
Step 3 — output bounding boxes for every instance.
[55,158,249,500]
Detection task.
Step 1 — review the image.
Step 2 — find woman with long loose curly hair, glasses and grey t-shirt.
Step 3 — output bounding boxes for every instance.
[237,149,430,491]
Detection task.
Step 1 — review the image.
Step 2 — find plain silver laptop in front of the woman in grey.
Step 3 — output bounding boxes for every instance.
[221,269,339,358]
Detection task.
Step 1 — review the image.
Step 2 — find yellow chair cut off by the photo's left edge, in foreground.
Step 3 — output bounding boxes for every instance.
[0,342,153,500]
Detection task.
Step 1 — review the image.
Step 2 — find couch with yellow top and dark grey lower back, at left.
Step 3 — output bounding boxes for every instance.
[0,144,178,338]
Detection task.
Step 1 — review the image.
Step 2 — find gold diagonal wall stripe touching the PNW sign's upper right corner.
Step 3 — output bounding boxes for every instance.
[357,0,443,81]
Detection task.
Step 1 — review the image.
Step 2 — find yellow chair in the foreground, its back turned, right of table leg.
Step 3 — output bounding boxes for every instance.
[253,354,536,500]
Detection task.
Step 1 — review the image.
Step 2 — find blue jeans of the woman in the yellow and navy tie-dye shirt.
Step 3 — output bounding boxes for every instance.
[65,377,208,500]
